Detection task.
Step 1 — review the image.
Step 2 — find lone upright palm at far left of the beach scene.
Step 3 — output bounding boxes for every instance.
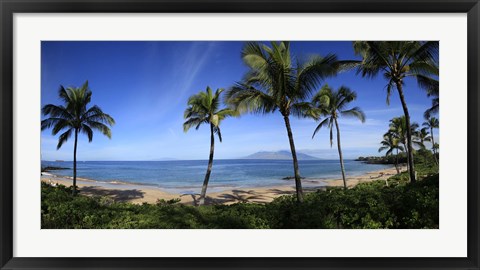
[41,81,115,195]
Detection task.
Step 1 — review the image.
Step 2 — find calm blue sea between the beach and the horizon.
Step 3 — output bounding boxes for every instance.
[42,159,390,193]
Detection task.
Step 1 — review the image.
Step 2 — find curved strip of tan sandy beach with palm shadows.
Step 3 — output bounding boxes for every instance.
[41,167,406,205]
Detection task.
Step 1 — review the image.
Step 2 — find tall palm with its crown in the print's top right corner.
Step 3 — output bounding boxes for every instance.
[353,41,438,182]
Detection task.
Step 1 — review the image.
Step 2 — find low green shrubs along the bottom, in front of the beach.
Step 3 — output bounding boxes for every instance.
[42,159,439,229]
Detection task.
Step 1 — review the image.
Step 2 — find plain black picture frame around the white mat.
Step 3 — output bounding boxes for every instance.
[0,0,480,270]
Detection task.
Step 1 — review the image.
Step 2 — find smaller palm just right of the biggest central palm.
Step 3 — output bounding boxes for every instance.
[312,85,365,188]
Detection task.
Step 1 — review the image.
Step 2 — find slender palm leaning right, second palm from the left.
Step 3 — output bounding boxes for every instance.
[183,87,237,205]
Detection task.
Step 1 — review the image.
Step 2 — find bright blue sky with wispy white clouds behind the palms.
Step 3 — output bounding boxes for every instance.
[41,41,438,160]
